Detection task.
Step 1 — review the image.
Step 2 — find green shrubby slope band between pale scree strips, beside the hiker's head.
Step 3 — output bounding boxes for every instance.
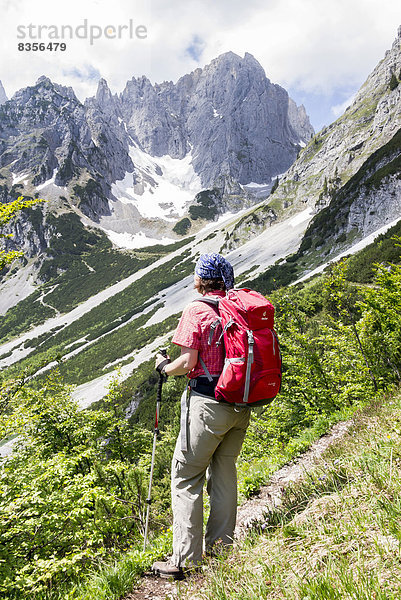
[3,251,193,384]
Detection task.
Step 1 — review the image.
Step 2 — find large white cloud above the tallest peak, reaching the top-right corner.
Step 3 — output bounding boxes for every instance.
[195,0,401,94]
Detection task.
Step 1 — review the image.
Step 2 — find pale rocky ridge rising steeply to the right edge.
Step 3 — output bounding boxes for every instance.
[276,26,401,213]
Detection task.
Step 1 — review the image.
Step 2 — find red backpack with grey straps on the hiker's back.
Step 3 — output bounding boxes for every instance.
[197,288,281,406]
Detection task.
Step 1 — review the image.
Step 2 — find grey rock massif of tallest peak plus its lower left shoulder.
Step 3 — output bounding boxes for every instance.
[114,52,314,187]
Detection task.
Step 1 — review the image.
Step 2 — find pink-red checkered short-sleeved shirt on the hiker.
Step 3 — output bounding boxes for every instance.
[172,292,226,379]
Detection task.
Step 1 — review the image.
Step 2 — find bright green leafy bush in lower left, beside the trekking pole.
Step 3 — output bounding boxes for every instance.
[0,375,176,598]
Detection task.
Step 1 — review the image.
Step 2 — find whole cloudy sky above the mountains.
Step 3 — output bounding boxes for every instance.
[0,0,401,131]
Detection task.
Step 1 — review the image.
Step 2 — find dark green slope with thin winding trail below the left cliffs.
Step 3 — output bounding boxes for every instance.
[0,209,191,342]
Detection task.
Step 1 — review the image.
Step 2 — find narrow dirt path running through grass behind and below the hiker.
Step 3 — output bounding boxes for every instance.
[124,421,352,600]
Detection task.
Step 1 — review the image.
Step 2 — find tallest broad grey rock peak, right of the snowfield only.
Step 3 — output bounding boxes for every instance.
[177,52,314,185]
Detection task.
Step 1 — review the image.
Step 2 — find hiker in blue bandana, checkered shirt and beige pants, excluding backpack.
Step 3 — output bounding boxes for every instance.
[153,254,250,579]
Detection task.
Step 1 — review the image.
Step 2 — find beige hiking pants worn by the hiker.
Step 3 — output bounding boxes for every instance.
[171,391,250,567]
